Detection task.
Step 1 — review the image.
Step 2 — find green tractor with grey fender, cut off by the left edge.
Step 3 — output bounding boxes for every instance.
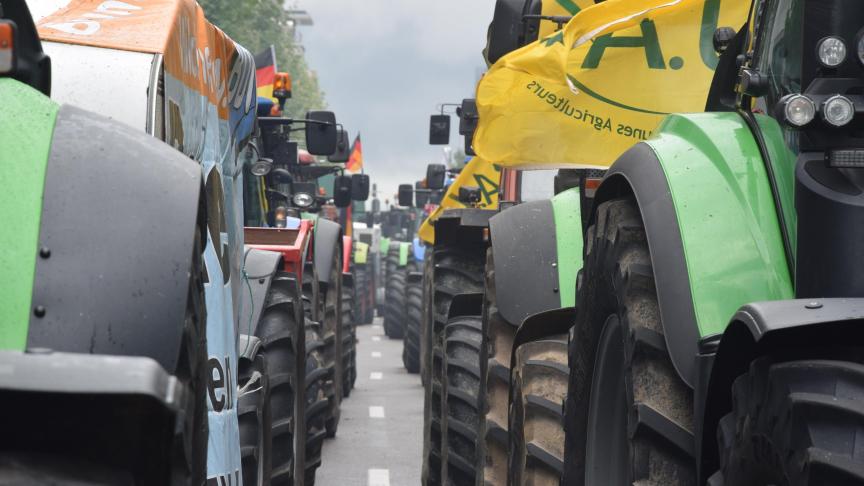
[0,0,206,486]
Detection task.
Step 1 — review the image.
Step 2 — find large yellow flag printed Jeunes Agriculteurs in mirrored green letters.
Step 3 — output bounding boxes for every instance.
[474,0,750,169]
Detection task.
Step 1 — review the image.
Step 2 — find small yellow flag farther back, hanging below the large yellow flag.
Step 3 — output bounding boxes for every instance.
[417,157,501,244]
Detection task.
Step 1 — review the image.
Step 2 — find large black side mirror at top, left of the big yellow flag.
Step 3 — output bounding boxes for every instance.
[484,0,542,66]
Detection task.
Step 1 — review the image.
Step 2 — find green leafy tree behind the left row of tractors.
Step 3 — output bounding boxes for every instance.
[199,0,327,118]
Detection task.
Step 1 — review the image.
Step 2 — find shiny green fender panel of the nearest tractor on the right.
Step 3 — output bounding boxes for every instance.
[647,113,794,337]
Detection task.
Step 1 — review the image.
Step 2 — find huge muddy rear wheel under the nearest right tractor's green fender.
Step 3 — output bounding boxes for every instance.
[563,198,696,486]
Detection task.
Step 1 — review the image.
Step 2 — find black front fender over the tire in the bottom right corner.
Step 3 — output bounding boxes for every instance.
[696,298,864,484]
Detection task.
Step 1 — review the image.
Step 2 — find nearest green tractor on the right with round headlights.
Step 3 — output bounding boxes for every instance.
[552,0,864,486]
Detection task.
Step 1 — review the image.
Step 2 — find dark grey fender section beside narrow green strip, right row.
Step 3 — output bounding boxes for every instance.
[489,200,561,326]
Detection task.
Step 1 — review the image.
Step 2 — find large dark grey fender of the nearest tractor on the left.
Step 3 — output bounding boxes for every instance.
[26,105,207,373]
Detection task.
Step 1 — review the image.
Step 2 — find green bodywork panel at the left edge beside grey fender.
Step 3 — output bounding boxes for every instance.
[0,78,59,350]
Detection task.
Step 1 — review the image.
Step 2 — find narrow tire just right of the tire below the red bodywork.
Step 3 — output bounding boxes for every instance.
[303,265,333,485]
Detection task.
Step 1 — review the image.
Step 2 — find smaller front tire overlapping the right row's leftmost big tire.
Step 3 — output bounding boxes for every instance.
[441,315,483,486]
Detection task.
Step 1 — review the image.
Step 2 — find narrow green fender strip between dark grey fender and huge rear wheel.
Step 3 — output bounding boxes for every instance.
[552,187,582,308]
